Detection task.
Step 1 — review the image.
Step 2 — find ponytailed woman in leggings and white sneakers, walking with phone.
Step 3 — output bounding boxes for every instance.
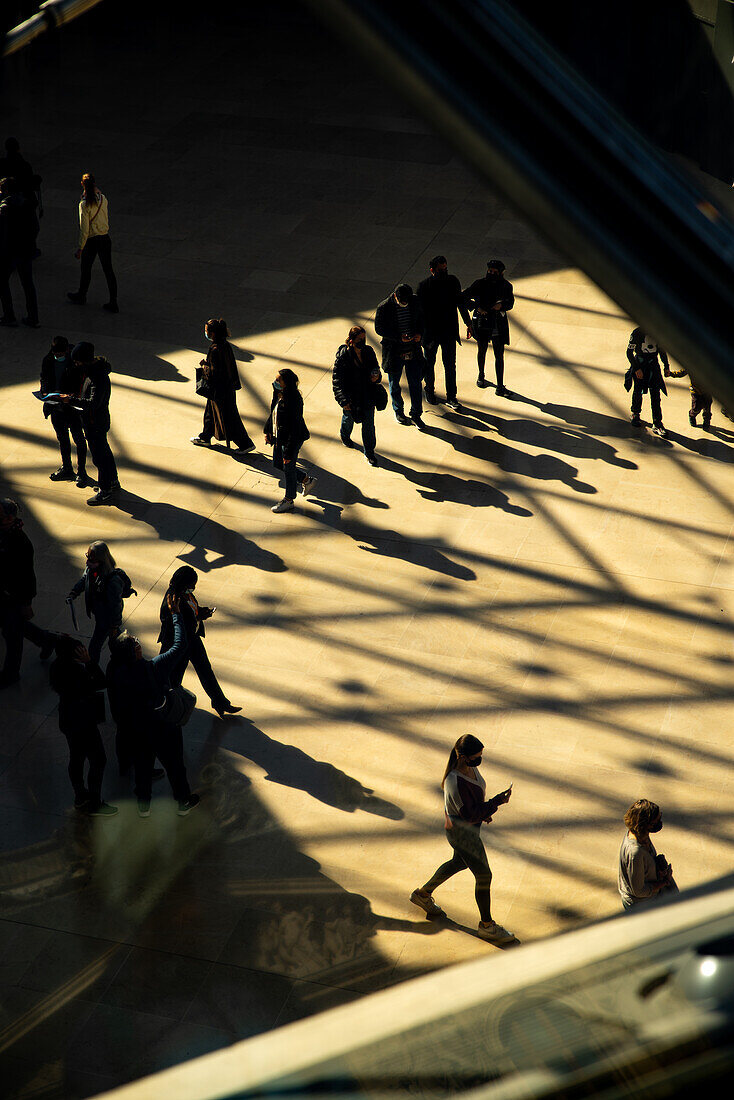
[410,734,515,944]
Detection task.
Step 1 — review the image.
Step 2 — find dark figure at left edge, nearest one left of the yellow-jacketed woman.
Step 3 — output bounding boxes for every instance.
[0,177,39,329]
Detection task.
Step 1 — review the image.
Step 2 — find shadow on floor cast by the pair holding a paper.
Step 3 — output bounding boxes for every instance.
[114,490,287,573]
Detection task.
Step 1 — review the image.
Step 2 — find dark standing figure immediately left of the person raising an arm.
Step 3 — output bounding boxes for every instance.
[48,635,118,817]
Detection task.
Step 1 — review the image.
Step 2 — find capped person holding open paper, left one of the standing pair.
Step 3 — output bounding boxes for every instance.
[41,337,87,488]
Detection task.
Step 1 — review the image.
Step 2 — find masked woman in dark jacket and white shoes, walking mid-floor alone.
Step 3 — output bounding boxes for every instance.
[263,366,316,513]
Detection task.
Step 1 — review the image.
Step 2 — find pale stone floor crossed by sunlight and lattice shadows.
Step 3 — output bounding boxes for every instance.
[0,0,734,1097]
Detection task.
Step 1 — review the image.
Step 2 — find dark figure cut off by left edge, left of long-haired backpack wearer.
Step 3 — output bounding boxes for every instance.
[0,499,56,688]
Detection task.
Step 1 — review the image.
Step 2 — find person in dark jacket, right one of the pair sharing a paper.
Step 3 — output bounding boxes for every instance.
[62,340,120,506]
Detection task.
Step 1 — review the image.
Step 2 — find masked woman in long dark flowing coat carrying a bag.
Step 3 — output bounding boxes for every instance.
[191,317,255,454]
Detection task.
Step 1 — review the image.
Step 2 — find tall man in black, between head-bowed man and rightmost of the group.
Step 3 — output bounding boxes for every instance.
[417,256,471,409]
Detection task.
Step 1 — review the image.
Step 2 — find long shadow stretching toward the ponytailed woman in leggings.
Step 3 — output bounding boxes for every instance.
[208,718,405,821]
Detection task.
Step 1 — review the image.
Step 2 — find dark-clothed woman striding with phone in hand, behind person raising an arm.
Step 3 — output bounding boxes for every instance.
[158,565,242,718]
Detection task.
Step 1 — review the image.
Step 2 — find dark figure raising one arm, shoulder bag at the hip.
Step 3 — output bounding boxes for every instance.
[107,596,199,817]
